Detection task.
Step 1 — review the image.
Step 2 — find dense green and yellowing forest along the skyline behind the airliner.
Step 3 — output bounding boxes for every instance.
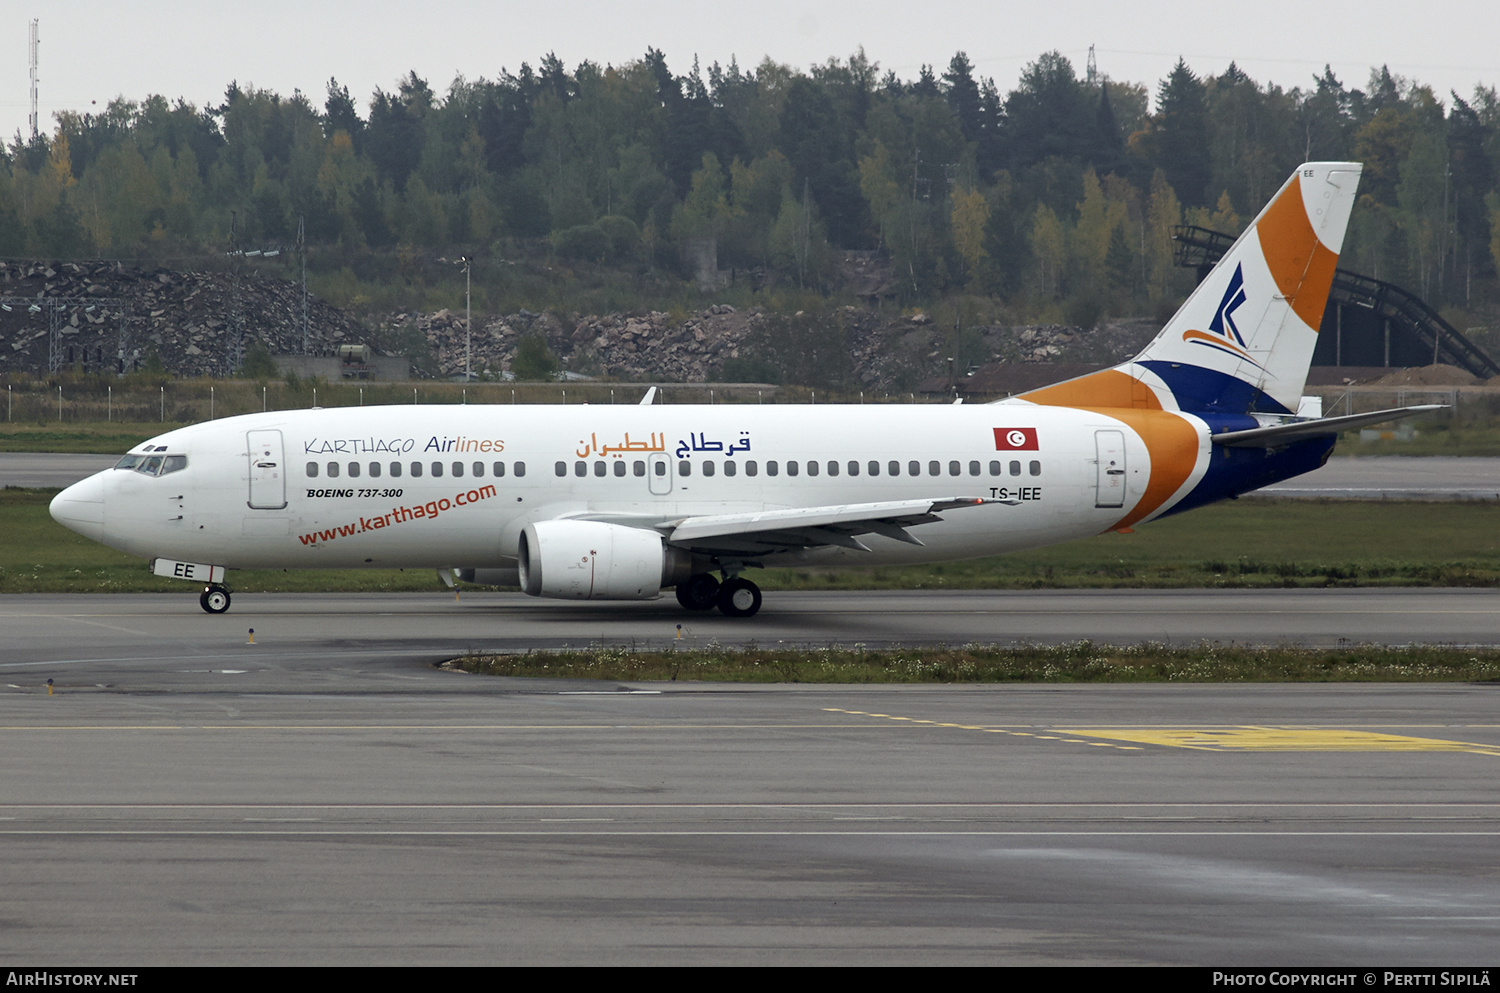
[0,50,1500,326]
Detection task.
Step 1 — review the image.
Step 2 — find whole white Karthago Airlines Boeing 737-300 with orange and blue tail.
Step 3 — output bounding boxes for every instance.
[51,162,1431,617]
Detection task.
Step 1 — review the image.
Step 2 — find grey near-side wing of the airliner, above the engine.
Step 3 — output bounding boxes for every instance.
[657,497,999,555]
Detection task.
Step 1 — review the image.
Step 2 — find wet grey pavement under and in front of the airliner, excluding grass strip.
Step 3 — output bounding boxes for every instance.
[0,591,1500,966]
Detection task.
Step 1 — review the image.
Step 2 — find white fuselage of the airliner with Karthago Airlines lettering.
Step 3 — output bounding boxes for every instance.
[54,404,1188,569]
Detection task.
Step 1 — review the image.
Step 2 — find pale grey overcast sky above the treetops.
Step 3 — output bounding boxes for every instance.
[0,0,1500,143]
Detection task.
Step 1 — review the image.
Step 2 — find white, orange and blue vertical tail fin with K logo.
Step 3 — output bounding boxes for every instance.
[1023,162,1362,414]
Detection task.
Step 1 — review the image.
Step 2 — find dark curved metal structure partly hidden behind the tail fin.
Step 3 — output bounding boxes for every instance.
[1172,225,1500,380]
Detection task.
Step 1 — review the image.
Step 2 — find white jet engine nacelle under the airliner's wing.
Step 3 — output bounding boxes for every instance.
[516,521,692,600]
